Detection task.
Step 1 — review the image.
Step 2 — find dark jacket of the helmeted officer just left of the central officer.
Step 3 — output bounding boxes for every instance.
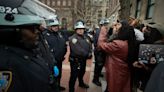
[44,31,66,61]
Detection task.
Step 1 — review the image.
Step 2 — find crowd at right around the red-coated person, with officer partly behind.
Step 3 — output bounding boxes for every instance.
[93,18,163,92]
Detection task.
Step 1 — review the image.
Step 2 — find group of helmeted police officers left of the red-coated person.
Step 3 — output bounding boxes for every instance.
[0,0,92,92]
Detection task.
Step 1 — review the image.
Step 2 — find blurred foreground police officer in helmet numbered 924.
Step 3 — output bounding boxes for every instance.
[0,0,56,92]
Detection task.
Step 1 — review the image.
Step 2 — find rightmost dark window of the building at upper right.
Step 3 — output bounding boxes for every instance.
[146,0,155,19]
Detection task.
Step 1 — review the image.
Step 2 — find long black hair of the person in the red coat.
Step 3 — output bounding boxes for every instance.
[118,20,137,64]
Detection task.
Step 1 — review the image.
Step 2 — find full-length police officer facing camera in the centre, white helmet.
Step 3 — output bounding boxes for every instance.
[69,21,91,92]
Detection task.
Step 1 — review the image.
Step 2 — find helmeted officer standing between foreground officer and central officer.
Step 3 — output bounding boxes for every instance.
[44,18,67,90]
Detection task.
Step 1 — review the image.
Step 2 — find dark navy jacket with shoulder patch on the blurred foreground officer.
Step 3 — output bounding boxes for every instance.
[0,46,50,92]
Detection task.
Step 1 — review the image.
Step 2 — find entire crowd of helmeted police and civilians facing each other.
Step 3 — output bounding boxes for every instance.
[0,0,164,92]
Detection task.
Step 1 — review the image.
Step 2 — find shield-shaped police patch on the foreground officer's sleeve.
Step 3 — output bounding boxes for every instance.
[0,71,12,92]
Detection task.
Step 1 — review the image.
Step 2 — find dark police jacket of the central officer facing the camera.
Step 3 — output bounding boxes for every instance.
[69,34,92,58]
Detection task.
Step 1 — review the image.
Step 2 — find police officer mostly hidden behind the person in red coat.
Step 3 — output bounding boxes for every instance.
[92,18,109,86]
